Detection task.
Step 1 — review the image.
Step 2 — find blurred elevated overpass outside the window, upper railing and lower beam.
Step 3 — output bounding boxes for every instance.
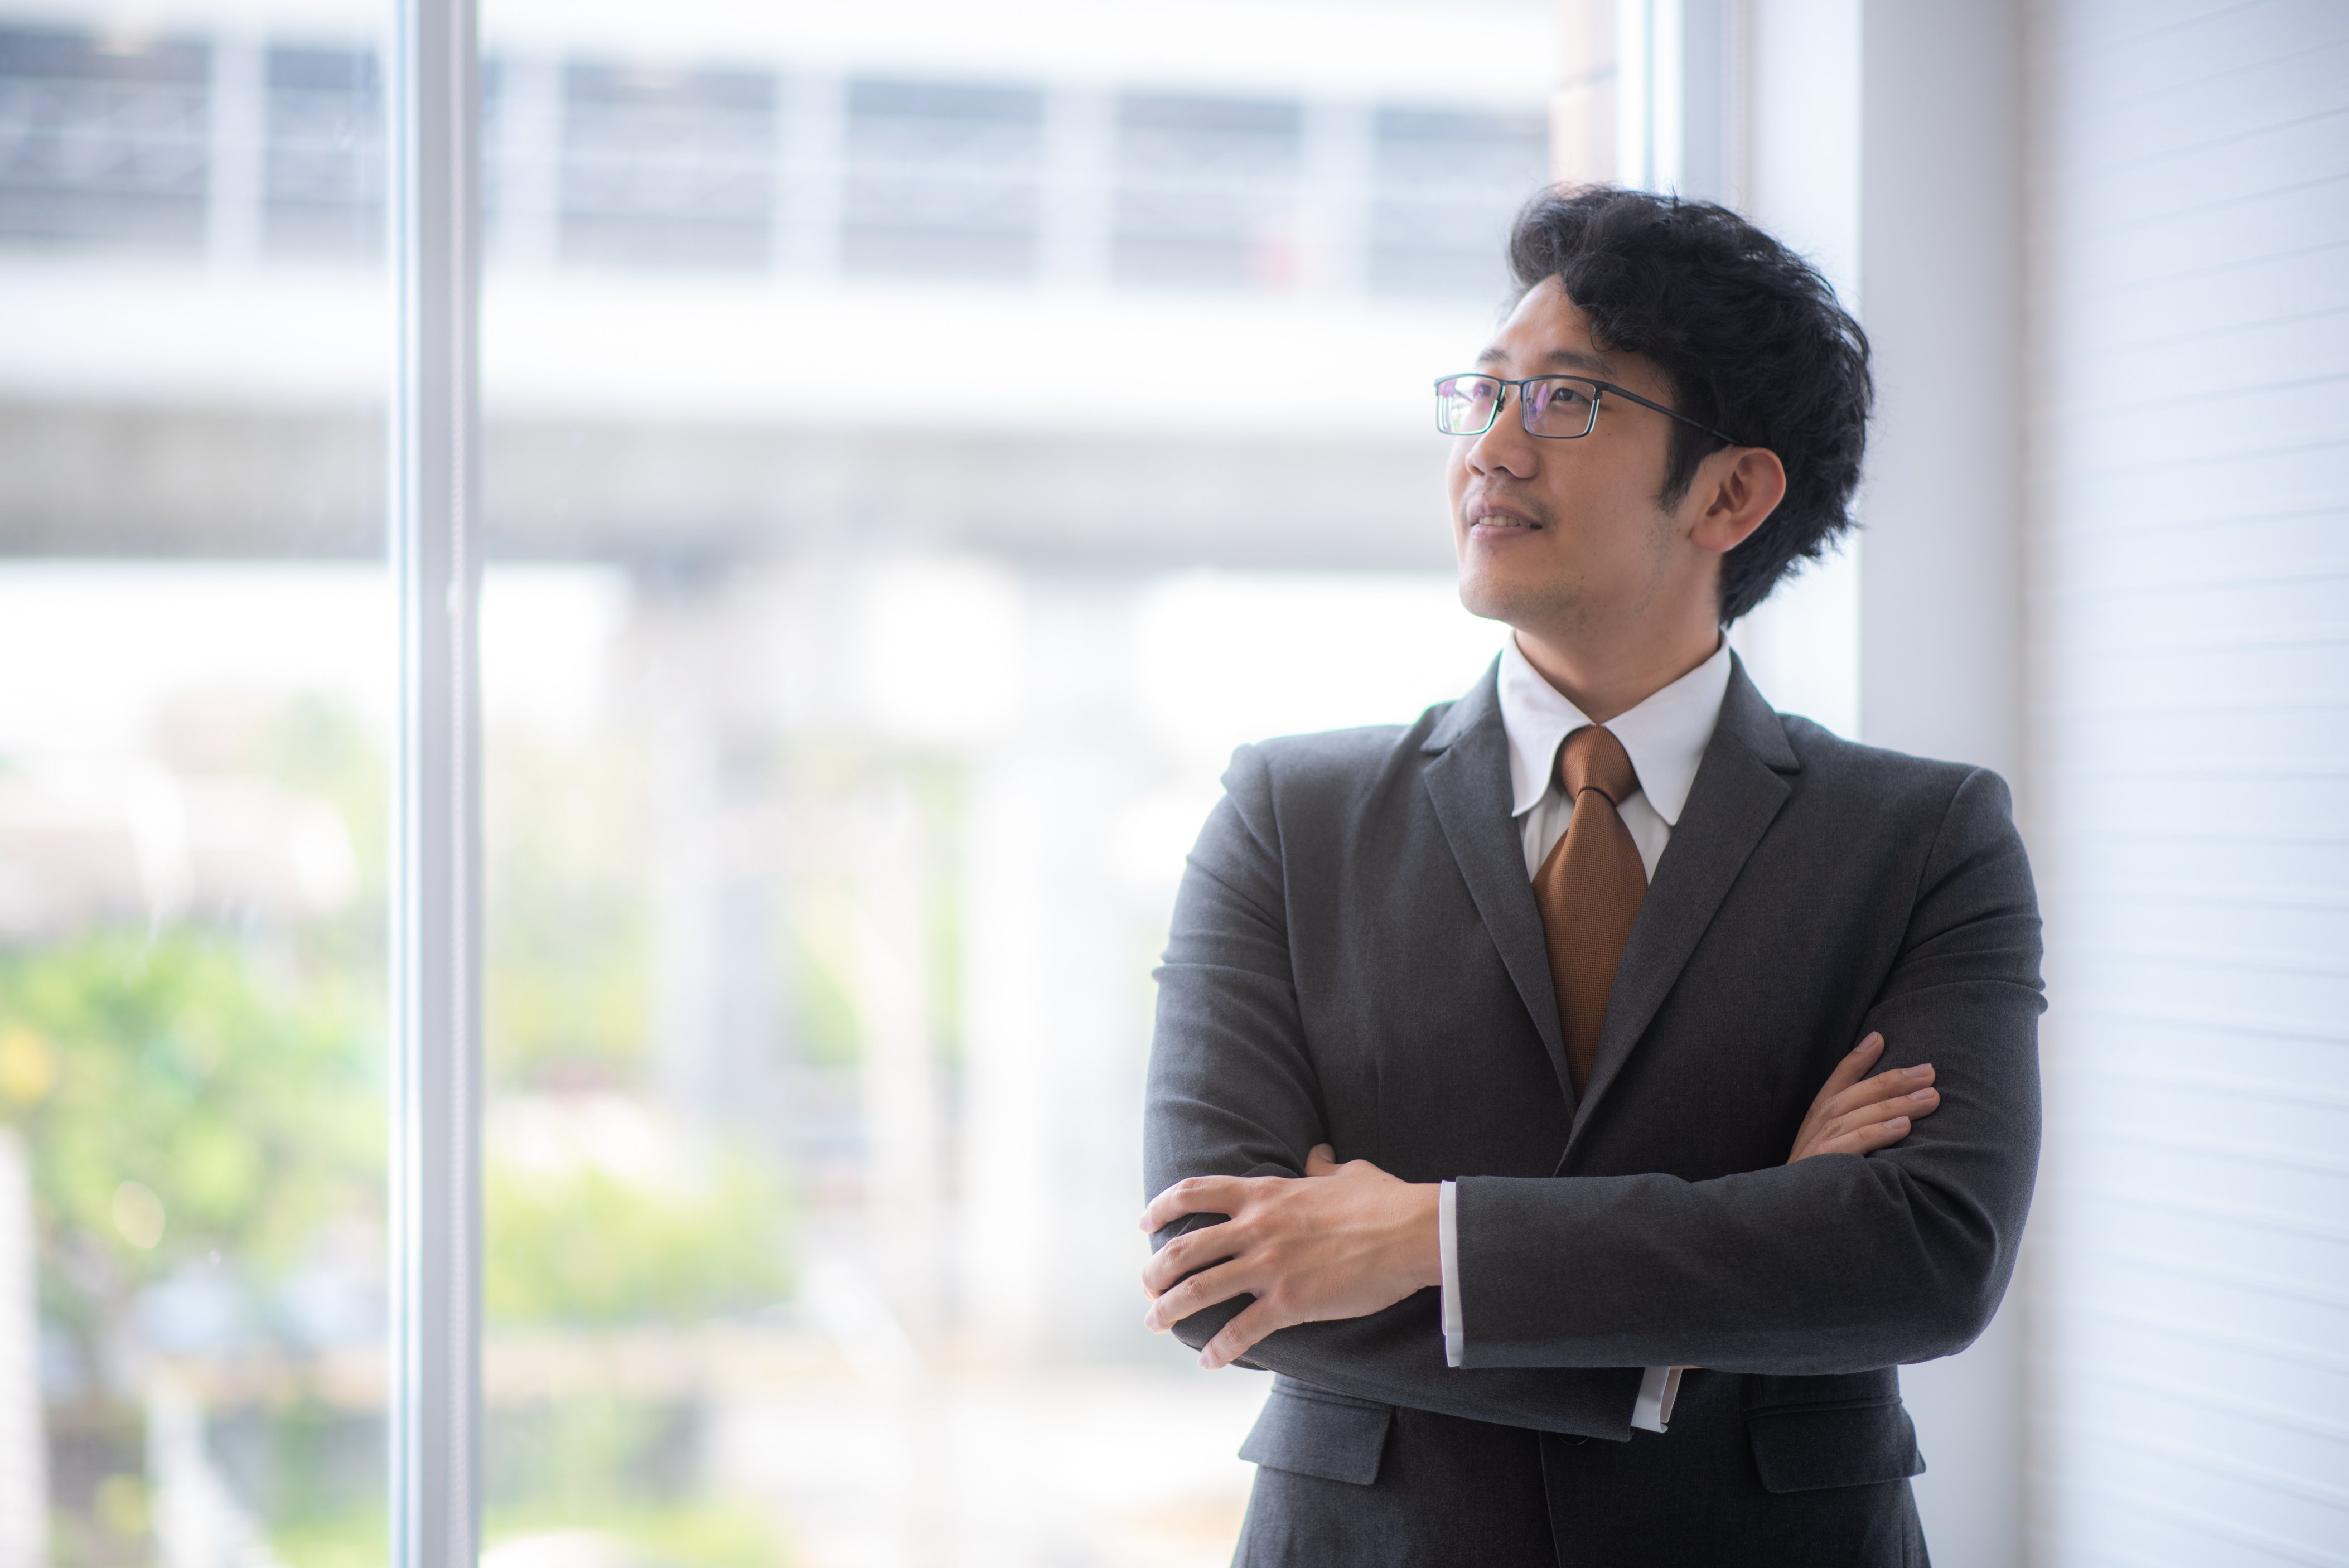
[0,2,1550,568]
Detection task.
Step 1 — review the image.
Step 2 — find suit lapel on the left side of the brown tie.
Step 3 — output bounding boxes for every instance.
[1423,664,1574,1108]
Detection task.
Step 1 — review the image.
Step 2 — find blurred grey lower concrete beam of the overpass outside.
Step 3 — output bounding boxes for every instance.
[0,401,1449,570]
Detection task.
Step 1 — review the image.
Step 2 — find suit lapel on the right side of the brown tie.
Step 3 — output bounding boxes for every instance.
[1578,655,1799,1148]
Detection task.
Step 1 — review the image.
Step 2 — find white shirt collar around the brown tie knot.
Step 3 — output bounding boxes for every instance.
[1499,636,1729,826]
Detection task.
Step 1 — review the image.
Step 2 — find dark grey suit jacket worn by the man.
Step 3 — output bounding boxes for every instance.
[1146,667,2043,1568]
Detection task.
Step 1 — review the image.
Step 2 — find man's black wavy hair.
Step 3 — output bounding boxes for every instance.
[1508,186,1874,625]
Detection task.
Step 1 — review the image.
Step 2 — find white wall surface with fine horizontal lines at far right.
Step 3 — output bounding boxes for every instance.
[2027,0,2349,1566]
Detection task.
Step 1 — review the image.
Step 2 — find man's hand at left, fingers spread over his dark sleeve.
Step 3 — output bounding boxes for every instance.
[1142,1143,1442,1368]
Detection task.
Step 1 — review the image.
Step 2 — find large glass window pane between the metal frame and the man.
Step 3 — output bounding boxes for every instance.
[481,0,1553,1568]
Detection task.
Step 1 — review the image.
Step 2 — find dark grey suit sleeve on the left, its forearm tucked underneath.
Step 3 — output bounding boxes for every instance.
[1144,747,1640,1441]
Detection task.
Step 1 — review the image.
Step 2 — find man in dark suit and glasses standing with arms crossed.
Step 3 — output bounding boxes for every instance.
[1144,190,2041,1568]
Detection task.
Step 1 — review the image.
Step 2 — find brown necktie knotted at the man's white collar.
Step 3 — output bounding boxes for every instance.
[1534,725,1647,1094]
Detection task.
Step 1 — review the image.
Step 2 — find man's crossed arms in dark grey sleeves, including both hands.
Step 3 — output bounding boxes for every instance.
[1146,768,2041,1436]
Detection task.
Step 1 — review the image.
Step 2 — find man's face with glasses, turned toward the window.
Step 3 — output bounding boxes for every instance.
[1444,277,1700,636]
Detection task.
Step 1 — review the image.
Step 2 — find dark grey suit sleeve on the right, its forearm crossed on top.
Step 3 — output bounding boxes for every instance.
[1456,770,2043,1376]
